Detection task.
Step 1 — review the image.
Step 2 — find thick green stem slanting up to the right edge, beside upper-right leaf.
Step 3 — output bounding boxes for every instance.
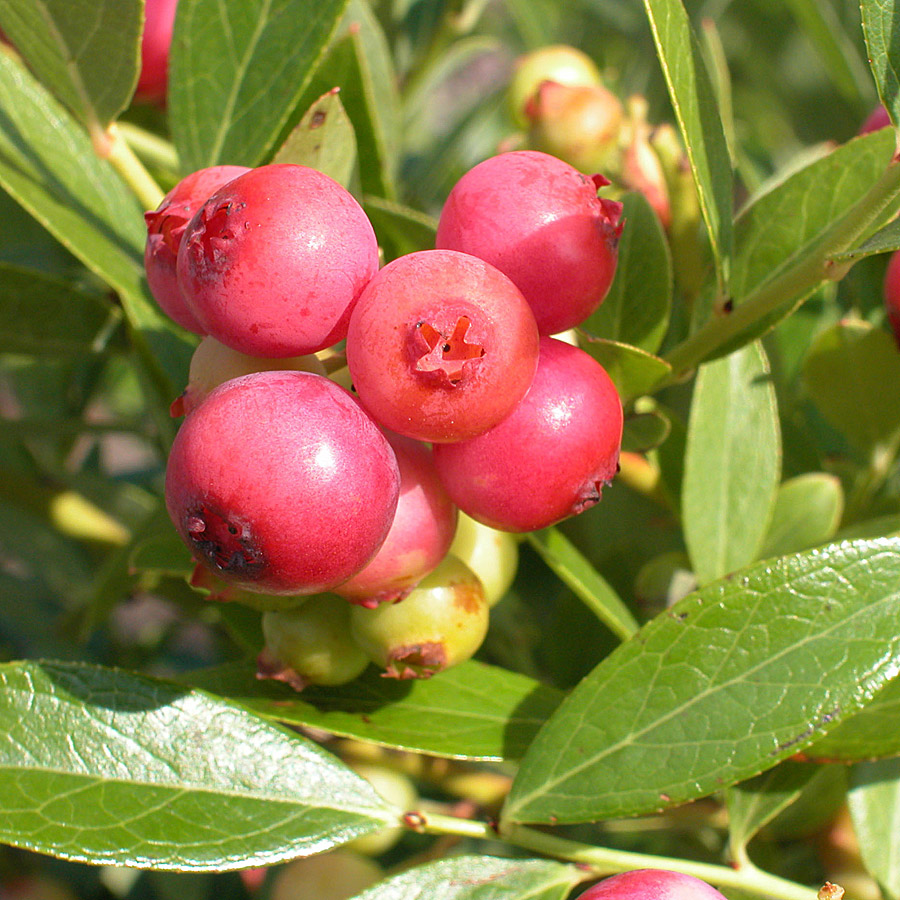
[657,161,900,389]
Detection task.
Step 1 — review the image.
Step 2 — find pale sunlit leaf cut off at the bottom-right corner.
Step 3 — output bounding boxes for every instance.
[847,759,900,900]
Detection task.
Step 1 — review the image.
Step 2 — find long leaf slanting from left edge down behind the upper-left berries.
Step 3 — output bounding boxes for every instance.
[0,54,193,410]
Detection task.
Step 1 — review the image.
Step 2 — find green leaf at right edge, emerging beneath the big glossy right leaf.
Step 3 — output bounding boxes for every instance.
[806,678,900,762]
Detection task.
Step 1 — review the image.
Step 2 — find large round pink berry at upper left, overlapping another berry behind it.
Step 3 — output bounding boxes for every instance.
[177,164,378,357]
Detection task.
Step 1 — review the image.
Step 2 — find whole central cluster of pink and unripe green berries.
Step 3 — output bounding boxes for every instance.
[145,151,622,687]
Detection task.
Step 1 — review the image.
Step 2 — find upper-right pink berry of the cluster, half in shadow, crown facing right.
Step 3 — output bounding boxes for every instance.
[435,150,622,334]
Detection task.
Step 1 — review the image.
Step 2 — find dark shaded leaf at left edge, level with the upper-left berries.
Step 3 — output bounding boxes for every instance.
[0,263,122,354]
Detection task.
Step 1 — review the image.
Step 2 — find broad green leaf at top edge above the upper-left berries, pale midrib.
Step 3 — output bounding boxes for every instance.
[169,0,347,172]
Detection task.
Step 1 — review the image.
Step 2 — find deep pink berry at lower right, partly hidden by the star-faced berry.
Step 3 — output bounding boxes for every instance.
[434,337,623,532]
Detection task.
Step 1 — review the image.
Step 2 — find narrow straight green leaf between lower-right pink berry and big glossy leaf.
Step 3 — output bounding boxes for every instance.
[528,528,638,640]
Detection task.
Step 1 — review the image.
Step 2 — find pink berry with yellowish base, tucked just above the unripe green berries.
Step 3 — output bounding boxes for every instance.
[334,432,456,606]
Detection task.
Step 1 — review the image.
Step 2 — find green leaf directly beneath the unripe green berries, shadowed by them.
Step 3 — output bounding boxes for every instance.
[189,662,562,759]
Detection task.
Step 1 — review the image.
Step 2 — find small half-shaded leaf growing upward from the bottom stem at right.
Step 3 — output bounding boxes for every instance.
[725,759,820,859]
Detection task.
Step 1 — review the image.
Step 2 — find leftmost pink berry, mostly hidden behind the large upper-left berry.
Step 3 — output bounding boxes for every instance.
[144,166,250,334]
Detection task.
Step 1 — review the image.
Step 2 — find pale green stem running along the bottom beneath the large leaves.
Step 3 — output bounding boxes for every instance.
[413,813,817,900]
